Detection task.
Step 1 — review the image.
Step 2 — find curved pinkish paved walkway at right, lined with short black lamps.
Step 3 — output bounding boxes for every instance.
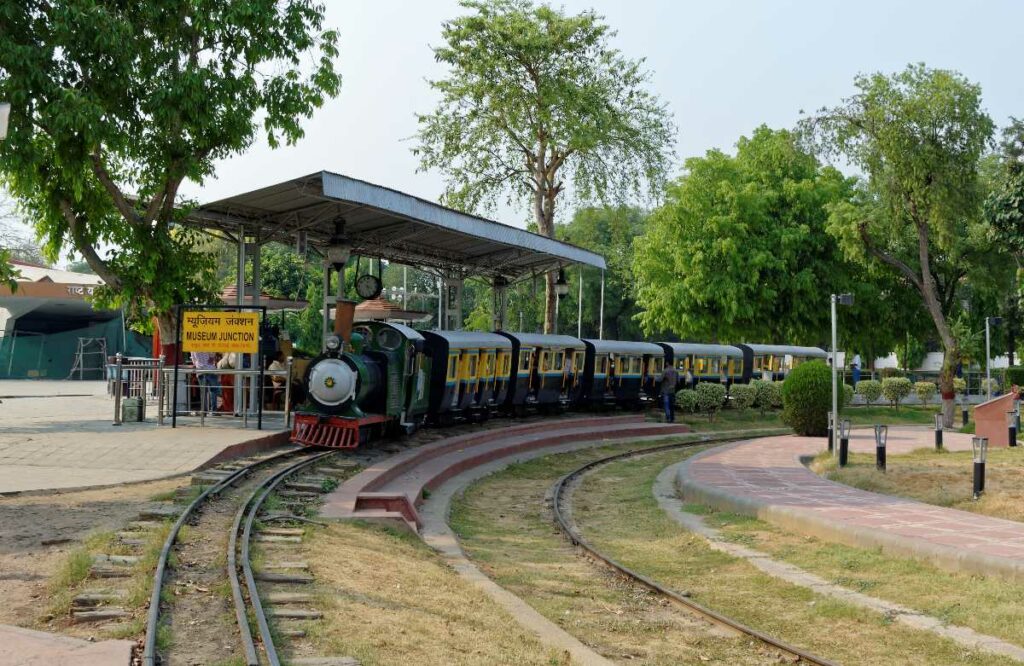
[677,427,1024,580]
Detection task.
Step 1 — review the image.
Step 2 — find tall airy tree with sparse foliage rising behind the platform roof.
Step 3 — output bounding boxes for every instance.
[415,0,675,332]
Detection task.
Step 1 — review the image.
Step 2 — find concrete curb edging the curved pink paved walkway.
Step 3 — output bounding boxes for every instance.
[676,440,1024,581]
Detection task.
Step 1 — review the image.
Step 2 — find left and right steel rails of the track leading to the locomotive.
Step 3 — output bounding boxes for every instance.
[142,449,334,666]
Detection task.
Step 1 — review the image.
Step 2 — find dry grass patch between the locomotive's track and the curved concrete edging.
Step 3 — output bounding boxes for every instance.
[299,523,565,666]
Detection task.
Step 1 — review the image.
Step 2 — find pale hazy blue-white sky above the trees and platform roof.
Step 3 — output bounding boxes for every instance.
[183,0,1024,226]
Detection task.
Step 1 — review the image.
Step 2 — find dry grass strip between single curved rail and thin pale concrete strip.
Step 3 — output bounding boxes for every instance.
[575,446,1014,665]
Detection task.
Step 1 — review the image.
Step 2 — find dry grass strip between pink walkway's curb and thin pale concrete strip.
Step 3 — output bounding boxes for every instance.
[704,505,1024,644]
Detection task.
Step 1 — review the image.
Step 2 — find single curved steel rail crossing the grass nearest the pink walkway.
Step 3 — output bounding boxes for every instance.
[552,436,837,666]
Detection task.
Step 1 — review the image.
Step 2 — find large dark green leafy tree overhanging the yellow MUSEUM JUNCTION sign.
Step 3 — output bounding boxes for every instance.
[0,0,340,348]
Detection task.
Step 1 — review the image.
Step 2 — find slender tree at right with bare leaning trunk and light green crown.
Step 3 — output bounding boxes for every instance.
[804,65,993,426]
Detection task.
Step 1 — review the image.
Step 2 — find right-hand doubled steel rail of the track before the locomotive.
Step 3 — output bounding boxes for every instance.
[227,451,337,666]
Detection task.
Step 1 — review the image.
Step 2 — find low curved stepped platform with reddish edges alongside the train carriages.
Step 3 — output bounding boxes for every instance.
[321,414,689,532]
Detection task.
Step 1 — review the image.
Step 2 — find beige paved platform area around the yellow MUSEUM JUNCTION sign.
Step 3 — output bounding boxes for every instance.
[0,380,288,494]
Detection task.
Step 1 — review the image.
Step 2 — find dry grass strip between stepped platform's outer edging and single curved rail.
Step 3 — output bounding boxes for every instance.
[452,438,773,664]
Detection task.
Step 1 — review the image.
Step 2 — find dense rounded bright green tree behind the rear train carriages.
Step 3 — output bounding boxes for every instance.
[634,126,914,352]
